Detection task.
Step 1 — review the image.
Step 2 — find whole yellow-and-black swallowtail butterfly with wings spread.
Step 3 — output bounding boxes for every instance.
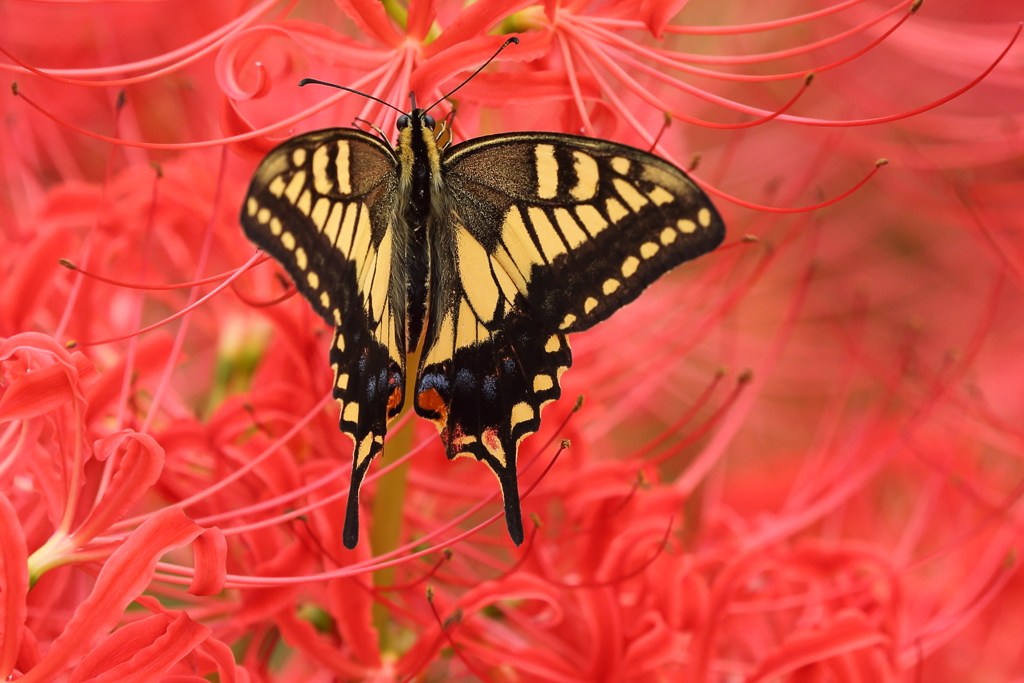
[241,44,725,548]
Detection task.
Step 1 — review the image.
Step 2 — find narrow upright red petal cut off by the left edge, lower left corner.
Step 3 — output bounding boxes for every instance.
[0,494,29,679]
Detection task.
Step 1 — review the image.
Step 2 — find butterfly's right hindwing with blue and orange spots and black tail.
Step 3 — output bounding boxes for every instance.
[414,213,572,545]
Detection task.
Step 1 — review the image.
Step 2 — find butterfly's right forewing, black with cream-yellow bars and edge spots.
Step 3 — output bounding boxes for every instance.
[442,133,725,334]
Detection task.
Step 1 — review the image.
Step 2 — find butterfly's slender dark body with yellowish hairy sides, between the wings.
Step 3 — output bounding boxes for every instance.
[397,109,440,353]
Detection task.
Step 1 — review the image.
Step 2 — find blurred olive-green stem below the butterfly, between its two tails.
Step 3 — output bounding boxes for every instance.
[370,354,419,652]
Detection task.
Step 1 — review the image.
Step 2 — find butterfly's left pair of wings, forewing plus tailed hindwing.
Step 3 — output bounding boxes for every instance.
[242,128,406,548]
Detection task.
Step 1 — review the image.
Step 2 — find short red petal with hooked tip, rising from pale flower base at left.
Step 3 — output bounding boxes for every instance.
[72,429,164,547]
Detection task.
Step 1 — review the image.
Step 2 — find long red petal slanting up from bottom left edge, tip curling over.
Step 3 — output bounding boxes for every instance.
[22,507,204,683]
